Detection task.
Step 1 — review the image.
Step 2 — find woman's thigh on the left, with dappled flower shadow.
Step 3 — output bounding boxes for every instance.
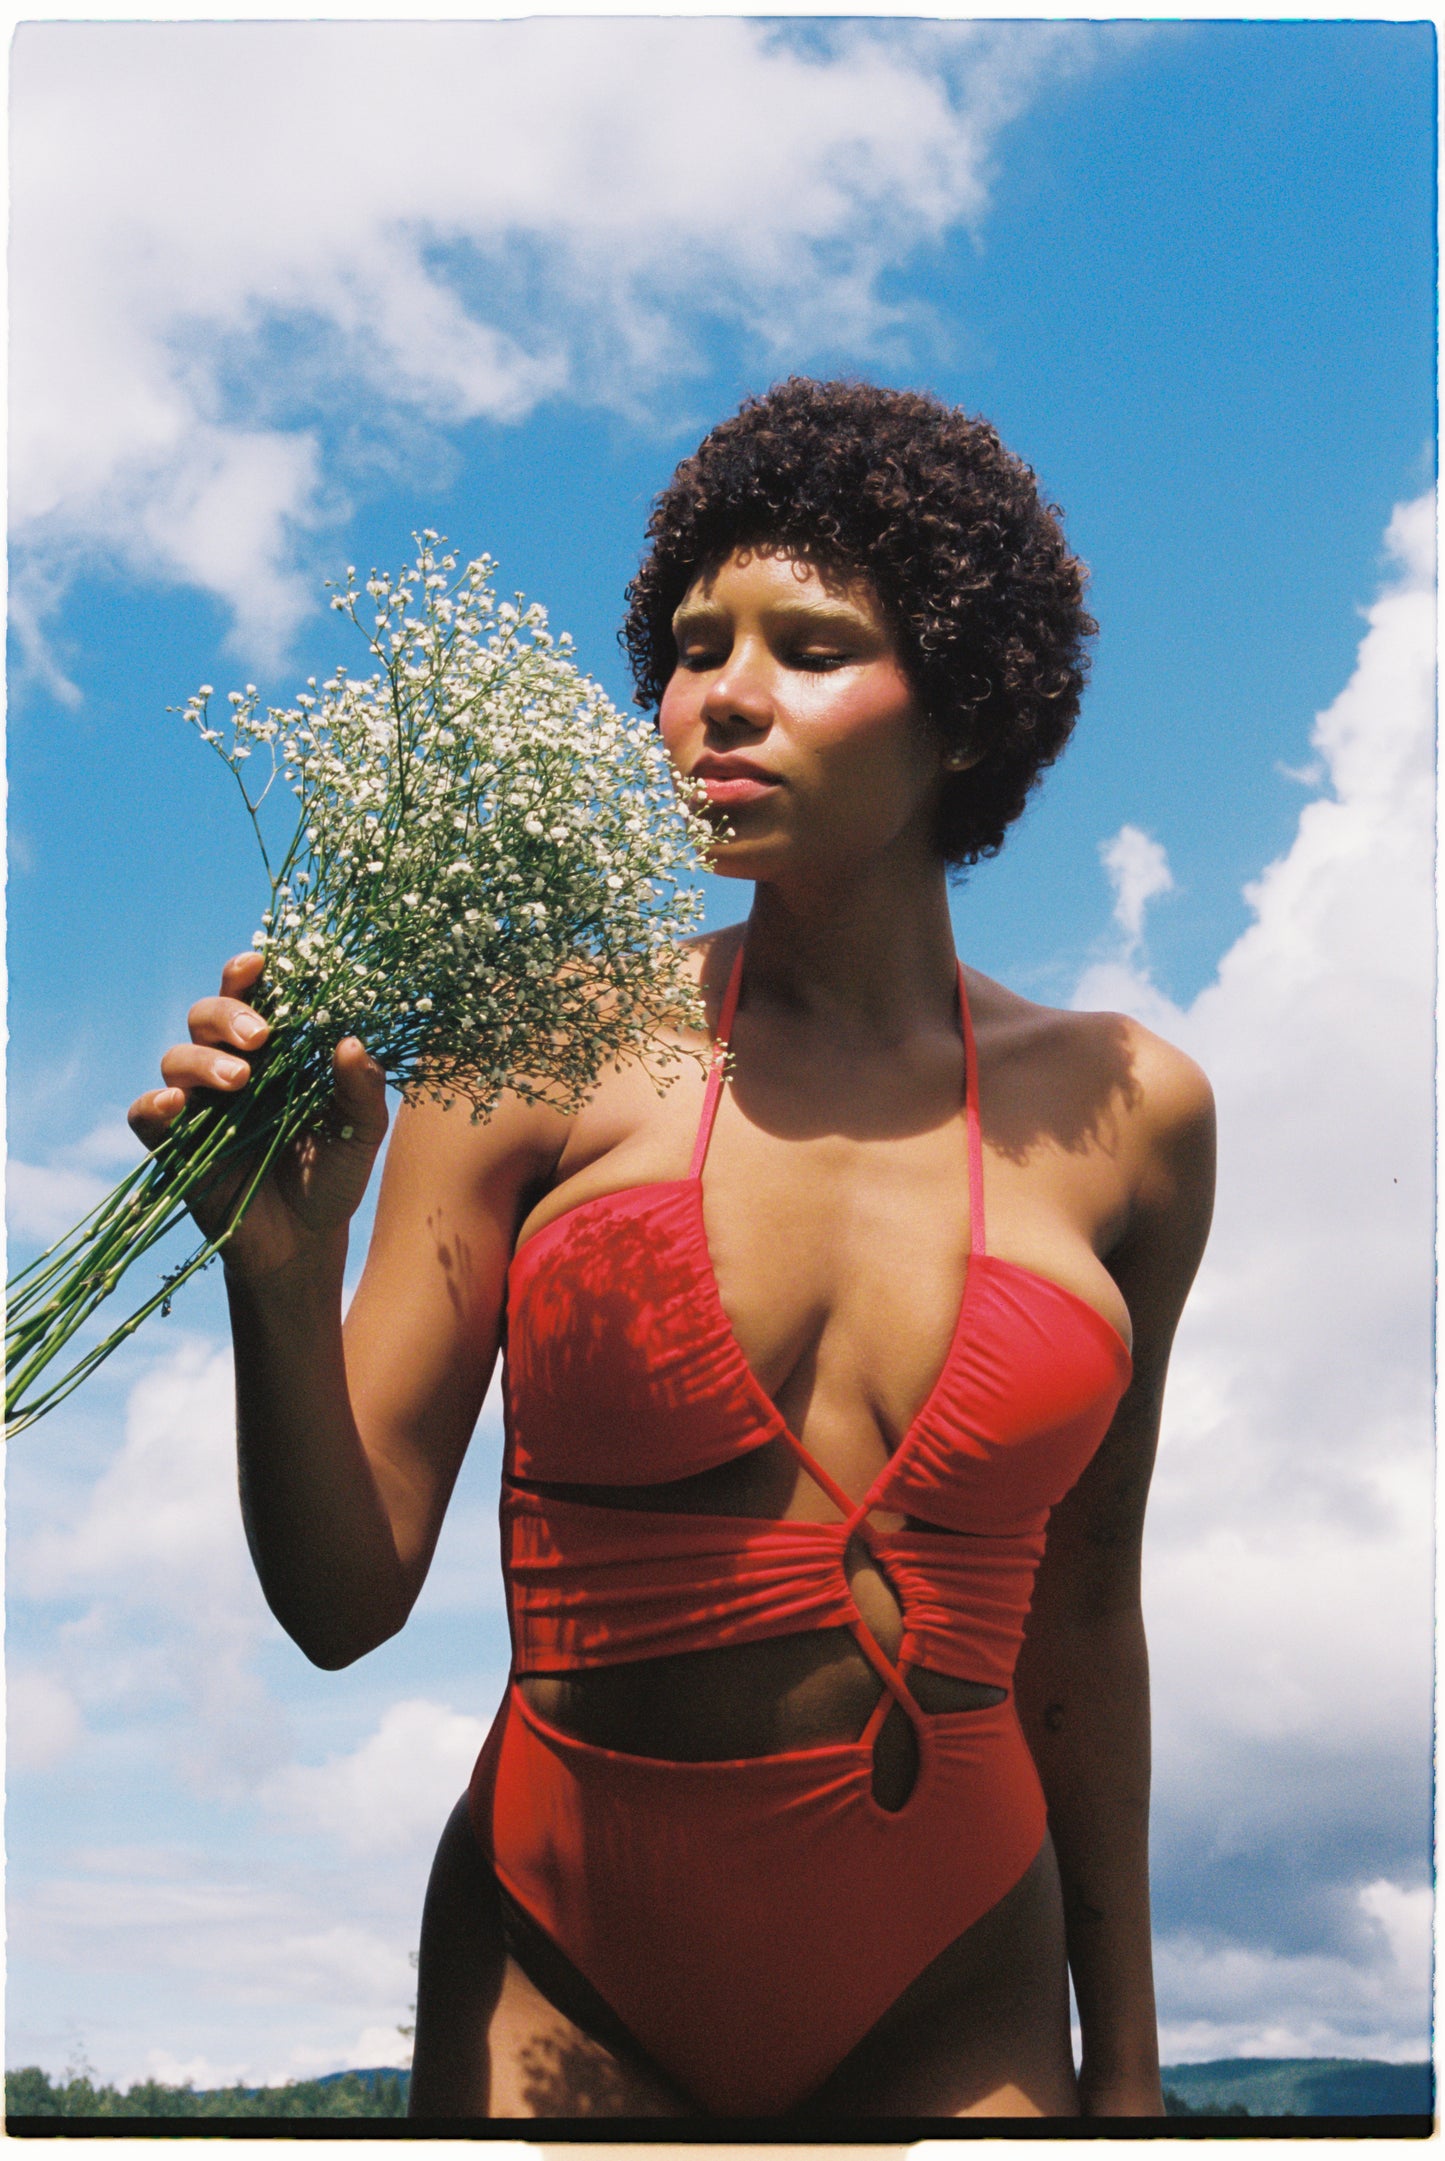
[410,1800,689,2118]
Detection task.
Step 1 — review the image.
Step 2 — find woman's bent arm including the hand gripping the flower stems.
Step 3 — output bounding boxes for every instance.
[132,955,566,1666]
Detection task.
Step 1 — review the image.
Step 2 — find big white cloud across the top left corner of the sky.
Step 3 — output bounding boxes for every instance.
[11,17,1097,669]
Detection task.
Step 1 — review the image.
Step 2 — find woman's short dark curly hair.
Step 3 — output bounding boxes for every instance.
[620,376,1097,869]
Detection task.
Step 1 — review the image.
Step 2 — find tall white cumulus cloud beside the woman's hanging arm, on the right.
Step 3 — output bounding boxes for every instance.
[1076,497,1434,2055]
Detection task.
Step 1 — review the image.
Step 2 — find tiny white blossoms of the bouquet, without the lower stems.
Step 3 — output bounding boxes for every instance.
[177,540,708,1109]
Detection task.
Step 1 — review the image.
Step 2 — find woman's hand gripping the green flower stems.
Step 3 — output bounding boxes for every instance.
[127,953,387,1281]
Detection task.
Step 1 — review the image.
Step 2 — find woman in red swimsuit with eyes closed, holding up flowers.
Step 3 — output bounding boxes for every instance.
[132,380,1212,2118]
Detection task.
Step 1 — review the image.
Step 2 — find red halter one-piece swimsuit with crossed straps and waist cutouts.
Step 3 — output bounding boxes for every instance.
[471,955,1130,2116]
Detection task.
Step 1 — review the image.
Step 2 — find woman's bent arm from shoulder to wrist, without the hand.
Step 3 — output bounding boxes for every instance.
[227,1104,559,1666]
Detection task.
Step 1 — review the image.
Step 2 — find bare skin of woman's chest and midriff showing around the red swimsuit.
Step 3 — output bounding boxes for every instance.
[501,934,1127,1772]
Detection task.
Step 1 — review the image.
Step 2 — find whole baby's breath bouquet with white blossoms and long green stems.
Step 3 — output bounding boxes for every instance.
[6,532,713,1433]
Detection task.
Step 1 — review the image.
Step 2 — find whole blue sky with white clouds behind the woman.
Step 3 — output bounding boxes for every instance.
[6,4,1436,2077]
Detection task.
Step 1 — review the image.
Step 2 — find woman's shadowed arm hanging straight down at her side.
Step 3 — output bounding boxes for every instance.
[1017,1031,1214,2116]
